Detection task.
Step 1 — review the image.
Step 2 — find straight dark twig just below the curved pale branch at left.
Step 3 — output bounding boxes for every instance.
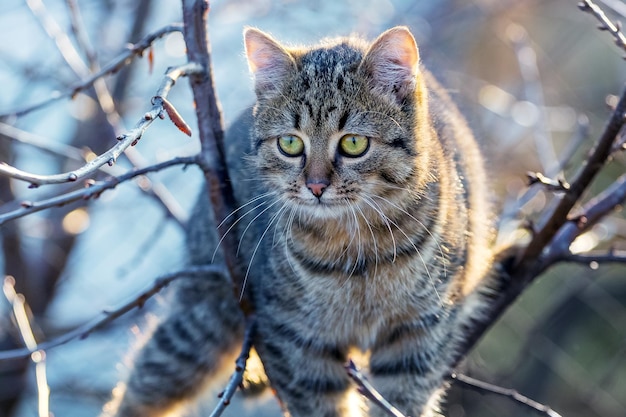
[0,156,198,226]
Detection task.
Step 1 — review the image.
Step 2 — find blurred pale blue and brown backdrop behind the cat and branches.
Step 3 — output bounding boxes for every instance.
[0,0,626,417]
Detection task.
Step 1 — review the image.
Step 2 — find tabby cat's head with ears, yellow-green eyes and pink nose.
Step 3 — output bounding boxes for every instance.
[244,27,426,217]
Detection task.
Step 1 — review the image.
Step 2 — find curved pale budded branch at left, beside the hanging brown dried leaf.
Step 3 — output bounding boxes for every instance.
[0,63,201,186]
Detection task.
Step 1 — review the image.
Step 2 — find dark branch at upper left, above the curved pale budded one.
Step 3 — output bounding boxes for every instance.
[0,24,182,119]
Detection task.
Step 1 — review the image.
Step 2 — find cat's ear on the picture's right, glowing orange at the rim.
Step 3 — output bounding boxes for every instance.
[359,26,419,103]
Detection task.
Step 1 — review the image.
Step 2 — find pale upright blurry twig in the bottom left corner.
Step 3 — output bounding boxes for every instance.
[2,276,50,417]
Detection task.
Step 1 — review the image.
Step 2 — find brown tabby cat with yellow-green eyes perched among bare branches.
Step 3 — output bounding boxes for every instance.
[102,27,492,417]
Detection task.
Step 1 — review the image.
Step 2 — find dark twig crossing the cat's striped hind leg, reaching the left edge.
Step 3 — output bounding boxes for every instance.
[0,265,227,362]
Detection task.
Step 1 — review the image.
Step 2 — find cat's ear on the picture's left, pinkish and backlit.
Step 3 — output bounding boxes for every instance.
[243,27,296,98]
